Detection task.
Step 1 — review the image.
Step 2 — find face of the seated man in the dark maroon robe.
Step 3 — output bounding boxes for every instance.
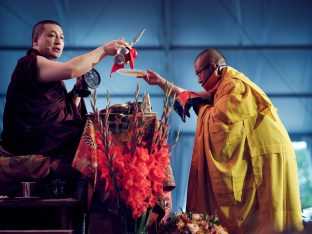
[33,24,64,59]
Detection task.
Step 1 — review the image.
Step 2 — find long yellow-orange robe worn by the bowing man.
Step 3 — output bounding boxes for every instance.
[187,67,303,234]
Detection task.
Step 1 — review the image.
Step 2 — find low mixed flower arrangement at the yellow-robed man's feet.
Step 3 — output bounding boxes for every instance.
[160,211,228,234]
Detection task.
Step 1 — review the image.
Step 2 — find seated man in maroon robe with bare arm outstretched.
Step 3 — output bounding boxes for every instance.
[1,20,128,164]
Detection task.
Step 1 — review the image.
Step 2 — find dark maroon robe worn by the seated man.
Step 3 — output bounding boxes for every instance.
[1,49,87,164]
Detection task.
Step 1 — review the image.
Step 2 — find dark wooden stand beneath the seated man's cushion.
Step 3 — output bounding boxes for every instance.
[0,198,85,234]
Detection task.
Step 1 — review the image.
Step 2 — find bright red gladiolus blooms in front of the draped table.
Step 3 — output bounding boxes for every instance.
[96,122,170,218]
